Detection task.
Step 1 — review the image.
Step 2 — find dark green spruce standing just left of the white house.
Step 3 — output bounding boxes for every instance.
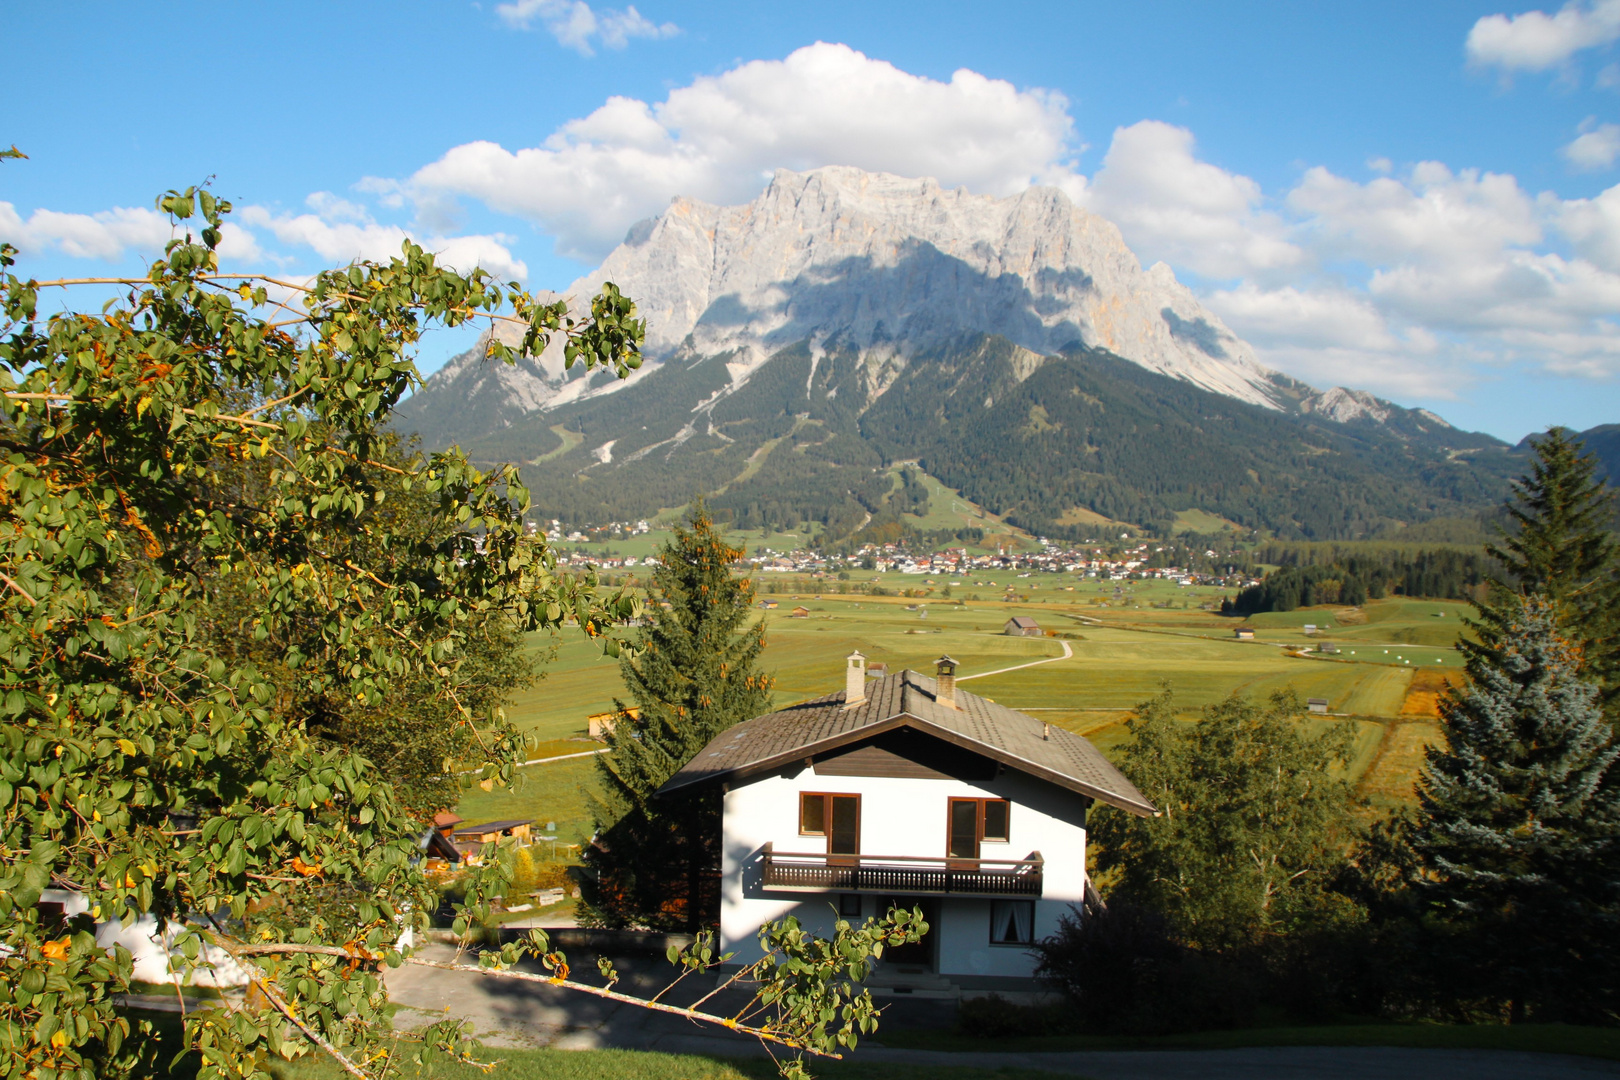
[580,502,771,931]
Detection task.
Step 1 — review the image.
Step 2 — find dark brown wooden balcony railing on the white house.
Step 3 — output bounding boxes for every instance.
[761,844,1045,897]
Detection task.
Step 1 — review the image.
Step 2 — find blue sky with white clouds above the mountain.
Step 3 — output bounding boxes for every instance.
[0,0,1620,439]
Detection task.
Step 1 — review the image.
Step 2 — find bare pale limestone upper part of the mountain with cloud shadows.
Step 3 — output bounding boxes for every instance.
[403,167,1419,440]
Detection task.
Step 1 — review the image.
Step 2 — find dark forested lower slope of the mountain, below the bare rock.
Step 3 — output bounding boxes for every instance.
[453,335,1518,539]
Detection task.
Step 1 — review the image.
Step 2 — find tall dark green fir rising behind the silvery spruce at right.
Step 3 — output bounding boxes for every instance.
[1461,427,1620,724]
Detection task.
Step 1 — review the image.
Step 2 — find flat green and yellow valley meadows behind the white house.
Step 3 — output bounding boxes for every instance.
[457,592,1466,842]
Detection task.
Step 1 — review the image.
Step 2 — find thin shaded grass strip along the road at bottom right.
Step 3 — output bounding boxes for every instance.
[878,1023,1620,1061]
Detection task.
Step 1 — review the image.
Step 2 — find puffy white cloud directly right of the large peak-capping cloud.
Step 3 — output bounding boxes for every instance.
[1089,120,1304,279]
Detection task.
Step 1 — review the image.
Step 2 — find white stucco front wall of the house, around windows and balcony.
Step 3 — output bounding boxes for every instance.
[721,766,1085,976]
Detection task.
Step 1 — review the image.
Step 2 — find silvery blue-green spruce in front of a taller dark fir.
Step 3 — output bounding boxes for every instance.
[1413,594,1620,1022]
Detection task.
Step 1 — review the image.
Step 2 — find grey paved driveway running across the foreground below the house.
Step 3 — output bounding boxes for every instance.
[387,944,1620,1080]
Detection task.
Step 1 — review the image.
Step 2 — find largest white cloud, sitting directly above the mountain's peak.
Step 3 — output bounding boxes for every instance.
[408,42,1082,261]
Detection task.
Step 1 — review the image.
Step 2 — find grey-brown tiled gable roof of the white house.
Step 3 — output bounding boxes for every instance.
[659,669,1153,814]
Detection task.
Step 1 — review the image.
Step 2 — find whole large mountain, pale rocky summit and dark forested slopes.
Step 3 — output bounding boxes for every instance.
[400,168,1524,542]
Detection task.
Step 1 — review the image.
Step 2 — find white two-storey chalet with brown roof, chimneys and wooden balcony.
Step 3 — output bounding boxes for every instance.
[661,653,1153,991]
